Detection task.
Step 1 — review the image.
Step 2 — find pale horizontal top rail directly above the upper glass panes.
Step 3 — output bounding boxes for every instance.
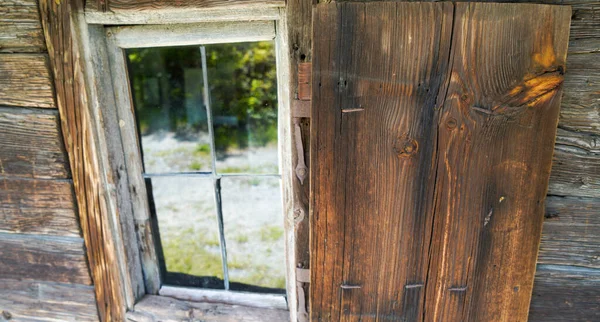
[107,21,275,48]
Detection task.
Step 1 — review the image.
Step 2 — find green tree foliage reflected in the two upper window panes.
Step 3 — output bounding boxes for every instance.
[127,42,277,152]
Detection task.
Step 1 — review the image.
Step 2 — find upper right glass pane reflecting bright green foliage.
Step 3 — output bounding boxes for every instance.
[206,42,279,174]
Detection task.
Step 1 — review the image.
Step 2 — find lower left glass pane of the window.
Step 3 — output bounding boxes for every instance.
[147,177,223,288]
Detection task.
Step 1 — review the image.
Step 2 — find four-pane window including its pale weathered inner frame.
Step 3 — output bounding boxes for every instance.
[101,20,296,319]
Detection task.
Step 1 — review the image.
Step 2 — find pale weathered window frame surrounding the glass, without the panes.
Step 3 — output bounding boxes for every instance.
[81,8,297,321]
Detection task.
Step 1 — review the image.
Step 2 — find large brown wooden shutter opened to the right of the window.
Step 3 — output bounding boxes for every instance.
[310,2,571,321]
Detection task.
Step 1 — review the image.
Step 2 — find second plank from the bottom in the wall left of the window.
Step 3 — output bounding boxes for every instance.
[0,233,92,285]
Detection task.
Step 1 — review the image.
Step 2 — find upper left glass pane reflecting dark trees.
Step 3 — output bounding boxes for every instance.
[127,46,212,173]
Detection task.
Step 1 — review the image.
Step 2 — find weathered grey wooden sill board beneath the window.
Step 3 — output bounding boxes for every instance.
[127,295,290,322]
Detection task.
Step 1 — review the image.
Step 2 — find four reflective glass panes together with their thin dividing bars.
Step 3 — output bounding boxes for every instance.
[126,42,285,293]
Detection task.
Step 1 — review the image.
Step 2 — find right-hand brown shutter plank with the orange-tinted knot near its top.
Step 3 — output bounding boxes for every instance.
[425,3,571,321]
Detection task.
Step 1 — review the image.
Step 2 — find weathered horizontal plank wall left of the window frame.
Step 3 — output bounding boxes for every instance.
[0,0,98,321]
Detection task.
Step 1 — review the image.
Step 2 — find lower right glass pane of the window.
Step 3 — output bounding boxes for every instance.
[221,177,285,292]
